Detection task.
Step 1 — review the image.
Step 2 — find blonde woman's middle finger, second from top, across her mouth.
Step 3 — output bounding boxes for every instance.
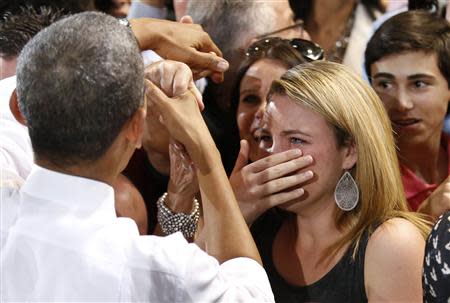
[256,155,313,184]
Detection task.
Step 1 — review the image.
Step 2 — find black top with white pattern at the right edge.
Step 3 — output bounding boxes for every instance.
[423,212,450,302]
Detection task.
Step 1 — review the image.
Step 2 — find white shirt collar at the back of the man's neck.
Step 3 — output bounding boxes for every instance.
[21,165,116,216]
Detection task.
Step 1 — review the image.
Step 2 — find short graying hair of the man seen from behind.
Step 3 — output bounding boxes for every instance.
[17,12,144,166]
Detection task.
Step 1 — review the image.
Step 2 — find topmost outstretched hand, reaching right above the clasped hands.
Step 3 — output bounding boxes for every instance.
[130,17,229,82]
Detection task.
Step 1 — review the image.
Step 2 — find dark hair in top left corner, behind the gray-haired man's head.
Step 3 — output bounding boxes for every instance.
[0,6,64,57]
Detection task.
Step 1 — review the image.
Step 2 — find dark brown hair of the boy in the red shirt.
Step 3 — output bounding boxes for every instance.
[365,10,450,87]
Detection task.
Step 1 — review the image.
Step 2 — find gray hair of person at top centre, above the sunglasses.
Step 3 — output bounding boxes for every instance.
[187,0,276,59]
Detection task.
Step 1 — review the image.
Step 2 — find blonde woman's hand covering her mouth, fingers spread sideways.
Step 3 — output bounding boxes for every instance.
[230,140,313,225]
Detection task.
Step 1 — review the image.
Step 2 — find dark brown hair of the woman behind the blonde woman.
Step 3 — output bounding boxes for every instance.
[231,39,308,127]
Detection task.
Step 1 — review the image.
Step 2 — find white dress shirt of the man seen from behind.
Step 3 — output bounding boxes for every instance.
[0,166,274,302]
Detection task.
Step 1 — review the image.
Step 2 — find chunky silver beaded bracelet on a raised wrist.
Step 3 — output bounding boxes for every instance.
[156,192,200,239]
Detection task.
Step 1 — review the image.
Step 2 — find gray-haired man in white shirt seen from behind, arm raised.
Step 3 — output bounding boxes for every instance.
[0,13,273,302]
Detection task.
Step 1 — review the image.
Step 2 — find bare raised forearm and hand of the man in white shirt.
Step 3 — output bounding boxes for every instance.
[147,81,261,264]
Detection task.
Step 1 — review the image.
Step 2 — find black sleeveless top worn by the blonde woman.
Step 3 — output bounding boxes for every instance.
[252,211,369,302]
